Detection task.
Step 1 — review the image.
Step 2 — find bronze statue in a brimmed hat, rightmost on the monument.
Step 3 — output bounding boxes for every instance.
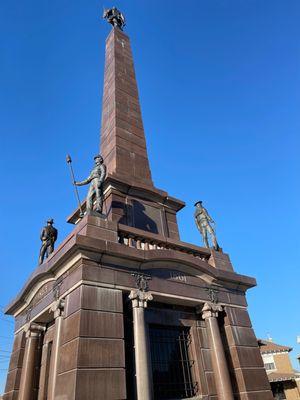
[194,201,220,250]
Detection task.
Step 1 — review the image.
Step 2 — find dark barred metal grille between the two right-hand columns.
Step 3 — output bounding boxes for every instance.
[150,325,197,400]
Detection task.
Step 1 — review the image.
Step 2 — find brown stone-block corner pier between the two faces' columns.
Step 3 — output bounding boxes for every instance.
[56,284,126,400]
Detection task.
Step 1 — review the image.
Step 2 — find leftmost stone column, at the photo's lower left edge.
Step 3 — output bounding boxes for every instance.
[18,323,45,400]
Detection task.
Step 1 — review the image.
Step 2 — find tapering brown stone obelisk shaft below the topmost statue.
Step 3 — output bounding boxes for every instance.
[101,29,153,187]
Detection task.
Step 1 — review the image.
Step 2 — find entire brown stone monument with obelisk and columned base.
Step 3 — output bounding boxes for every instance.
[4,8,272,400]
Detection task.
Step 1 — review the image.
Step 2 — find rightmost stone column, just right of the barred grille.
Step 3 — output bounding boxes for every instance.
[202,302,233,400]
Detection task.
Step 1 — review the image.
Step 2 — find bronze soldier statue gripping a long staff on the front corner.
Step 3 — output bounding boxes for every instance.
[74,154,106,214]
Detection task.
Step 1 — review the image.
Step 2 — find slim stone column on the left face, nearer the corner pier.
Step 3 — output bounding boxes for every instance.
[49,300,65,400]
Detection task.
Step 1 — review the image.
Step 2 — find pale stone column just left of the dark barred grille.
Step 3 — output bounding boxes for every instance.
[129,289,153,400]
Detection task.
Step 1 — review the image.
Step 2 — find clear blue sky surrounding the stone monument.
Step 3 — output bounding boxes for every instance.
[0,0,300,392]
